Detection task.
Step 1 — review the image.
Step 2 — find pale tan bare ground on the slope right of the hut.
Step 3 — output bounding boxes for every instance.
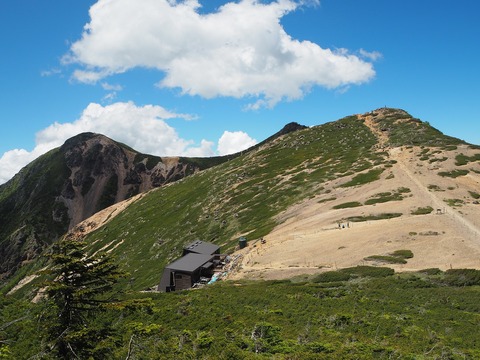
[230,132,480,279]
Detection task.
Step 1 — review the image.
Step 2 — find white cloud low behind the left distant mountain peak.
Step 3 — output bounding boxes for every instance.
[0,102,214,184]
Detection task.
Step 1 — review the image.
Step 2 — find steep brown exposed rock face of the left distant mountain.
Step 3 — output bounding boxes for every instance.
[56,133,198,228]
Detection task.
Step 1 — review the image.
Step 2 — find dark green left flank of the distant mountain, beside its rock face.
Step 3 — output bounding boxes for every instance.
[0,149,70,278]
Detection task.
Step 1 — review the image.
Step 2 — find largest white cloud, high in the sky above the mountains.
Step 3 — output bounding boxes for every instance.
[63,0,375,109]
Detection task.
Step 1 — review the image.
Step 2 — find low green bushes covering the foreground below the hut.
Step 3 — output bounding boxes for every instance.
[0,266,480,360]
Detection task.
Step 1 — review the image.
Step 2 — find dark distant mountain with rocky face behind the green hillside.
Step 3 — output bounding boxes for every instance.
[0,124,302,278]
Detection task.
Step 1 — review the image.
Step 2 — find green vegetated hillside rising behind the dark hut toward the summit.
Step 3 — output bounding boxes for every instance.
[77,111,406,289]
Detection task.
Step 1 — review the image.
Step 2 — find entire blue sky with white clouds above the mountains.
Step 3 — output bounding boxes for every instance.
[0,0,480,183]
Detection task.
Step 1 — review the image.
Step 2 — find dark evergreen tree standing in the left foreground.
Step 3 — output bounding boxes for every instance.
[40,240,125,359]
